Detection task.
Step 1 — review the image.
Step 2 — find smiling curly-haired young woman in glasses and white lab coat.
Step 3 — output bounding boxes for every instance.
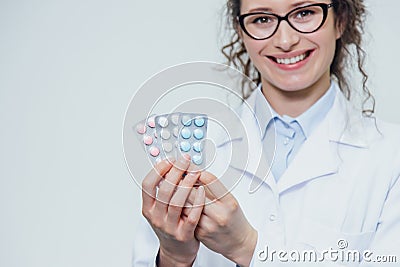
[134,0,400,267]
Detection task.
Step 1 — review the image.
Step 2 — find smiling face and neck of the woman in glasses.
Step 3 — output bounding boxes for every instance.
[239,1,341,114]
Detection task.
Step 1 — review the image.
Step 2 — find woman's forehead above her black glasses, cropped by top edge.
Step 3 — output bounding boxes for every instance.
[240,0,326,14]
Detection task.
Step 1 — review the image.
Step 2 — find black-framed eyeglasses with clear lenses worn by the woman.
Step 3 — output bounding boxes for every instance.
[238,3,333,40]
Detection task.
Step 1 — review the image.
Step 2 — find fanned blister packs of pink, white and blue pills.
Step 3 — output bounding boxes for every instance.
[135,113,208,168]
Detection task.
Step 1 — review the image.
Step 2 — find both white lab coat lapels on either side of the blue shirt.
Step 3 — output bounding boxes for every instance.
[214,90,368,193]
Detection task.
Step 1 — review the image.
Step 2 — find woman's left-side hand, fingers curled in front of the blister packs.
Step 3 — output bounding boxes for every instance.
[142,158,205,267]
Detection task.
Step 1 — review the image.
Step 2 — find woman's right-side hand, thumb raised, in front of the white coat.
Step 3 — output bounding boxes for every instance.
[185,172,258,266]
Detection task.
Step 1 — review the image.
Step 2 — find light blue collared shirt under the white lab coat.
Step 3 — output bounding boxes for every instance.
[254,82,337,181]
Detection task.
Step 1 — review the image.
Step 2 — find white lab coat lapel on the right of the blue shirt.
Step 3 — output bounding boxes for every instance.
[278,90,367,193]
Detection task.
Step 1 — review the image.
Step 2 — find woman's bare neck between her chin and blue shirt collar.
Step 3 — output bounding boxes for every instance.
[262,75,330,118]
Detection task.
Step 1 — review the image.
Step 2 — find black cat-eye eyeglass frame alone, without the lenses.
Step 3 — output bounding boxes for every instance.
[237,3,333,40]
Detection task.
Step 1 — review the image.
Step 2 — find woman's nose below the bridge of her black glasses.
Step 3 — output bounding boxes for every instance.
[272,21,300,51]
